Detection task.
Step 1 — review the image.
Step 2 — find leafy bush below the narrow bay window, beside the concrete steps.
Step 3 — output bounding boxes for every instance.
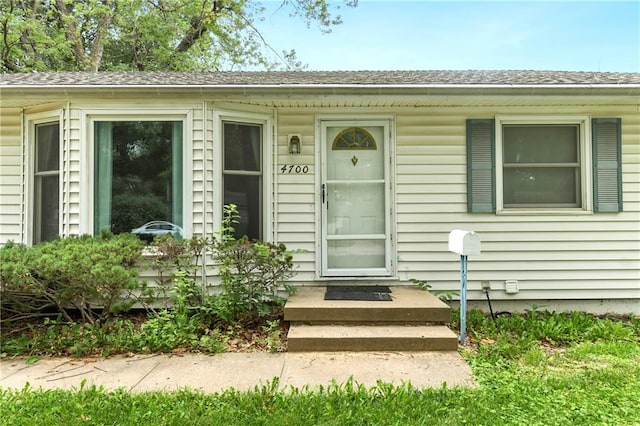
[141,208,293,323]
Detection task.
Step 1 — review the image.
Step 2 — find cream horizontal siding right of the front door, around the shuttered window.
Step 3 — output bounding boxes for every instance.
[396,107,640,299]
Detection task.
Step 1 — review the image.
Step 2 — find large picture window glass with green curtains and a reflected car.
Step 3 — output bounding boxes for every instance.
[94,120,183,242]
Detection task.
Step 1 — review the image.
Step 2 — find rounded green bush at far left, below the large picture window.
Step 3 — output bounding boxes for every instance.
[0,234,144,323]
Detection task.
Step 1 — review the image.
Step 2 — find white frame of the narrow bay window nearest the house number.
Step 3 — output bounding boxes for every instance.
[213,110,276,241]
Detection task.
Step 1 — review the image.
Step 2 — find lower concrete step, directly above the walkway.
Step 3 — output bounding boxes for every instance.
[288,324,458,352]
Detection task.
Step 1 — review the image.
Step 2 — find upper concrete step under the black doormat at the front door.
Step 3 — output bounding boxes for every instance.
[284,287,451,324]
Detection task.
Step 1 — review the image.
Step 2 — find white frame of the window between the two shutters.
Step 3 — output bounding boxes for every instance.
[495,115,593,214]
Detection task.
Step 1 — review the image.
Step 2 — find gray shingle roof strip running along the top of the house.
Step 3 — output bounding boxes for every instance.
[0,71,640,87]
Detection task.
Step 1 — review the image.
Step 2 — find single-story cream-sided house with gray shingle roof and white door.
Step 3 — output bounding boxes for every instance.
[0,71,640,314]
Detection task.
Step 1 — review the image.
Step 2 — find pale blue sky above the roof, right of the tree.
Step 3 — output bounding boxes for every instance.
[257,0,640,72]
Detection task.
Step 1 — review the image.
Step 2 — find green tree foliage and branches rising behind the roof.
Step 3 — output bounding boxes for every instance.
[0,0,358,72]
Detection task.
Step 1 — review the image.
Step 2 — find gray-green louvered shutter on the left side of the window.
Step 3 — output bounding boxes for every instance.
[467,119,496,213]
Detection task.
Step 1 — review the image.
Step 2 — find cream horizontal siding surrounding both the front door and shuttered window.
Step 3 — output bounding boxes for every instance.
[276,101,640,299]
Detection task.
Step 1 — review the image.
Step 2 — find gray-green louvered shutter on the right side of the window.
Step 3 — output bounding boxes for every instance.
[591,118,622,213]
